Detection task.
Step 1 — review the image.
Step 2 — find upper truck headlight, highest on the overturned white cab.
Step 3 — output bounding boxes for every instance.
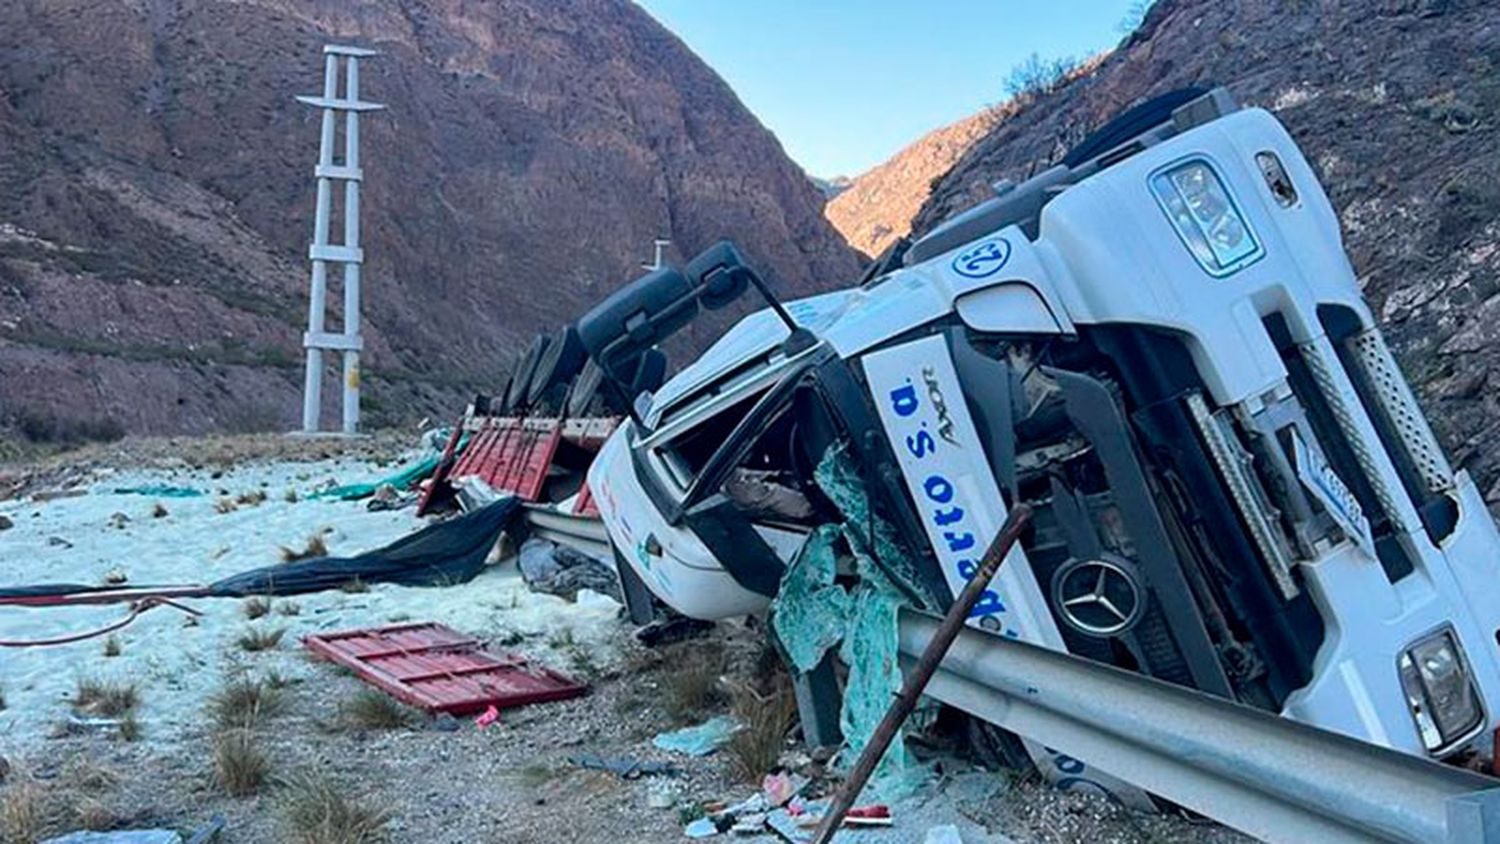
[1151,159,1262,276]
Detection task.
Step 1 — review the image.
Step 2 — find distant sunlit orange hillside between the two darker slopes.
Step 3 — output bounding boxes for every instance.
[824,109,1002,256]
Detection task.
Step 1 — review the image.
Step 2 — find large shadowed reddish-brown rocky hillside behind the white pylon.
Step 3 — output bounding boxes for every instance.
[0,0,857,438]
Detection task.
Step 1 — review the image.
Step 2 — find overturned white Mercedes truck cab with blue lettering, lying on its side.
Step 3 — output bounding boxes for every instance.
[579,88,1500,785]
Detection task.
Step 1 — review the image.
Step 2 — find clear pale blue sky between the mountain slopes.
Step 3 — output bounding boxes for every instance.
[638,0,1134,177]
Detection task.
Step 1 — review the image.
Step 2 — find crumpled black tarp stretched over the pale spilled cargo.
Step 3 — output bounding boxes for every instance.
[209,496,521,598]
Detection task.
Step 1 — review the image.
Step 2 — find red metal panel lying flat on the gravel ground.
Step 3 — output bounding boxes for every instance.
[302,624,587,715]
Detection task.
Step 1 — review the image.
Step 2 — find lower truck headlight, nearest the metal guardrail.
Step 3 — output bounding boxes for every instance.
[1397,630,1485,754]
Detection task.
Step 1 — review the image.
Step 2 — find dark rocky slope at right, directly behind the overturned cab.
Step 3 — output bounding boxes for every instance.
[888,0,1500,502]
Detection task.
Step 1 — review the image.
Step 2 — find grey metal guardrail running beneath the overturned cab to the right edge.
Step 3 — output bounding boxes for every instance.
[900,610,1500,844]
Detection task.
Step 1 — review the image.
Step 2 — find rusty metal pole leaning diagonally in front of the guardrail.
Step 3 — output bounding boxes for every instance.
[813,504,1032,844]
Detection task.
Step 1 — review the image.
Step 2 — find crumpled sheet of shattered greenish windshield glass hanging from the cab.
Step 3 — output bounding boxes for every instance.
[771,444,932,801]
